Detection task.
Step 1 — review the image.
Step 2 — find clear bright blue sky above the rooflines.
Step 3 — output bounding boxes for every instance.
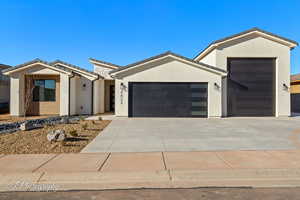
[0,0,300,73]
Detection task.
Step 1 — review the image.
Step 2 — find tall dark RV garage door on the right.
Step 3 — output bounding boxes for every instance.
[227,58,275,116]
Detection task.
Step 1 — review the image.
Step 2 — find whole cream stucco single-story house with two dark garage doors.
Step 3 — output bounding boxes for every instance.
[4,28,298,117]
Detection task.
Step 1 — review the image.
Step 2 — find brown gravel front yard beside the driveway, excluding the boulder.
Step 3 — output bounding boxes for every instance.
[0,120,110,154]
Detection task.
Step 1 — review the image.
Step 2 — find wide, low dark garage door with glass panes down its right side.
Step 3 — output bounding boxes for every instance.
[128,82,207,117]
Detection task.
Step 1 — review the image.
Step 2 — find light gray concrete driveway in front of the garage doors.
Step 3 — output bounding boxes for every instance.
[82,117,300,152]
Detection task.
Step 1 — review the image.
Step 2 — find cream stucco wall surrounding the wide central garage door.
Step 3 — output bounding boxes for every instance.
[115,60,222,117]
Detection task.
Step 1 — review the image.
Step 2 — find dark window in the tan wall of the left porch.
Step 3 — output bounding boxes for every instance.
[33,80,55,101]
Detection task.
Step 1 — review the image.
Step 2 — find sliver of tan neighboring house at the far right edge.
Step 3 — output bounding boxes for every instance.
[291,74,300,113]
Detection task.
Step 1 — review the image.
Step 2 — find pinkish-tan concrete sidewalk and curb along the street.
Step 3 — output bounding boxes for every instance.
[0,150,300,191]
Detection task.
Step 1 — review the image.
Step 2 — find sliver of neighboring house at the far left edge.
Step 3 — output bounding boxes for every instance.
[0,64,11,113]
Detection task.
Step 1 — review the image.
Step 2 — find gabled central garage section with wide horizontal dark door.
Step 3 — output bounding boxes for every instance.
[111,52,227,118]
